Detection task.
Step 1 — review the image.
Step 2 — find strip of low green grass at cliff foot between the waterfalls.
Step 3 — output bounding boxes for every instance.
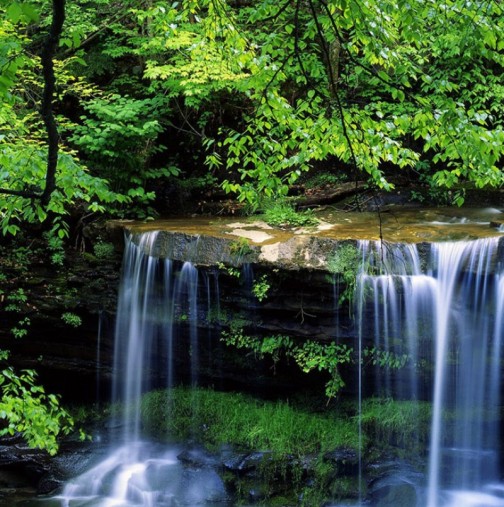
[141,388,358,456]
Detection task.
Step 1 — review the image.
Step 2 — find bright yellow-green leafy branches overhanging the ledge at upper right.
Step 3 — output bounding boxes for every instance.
[138,0,503,203]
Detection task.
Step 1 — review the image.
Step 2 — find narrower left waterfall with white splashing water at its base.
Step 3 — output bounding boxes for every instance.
[50,232,229,507]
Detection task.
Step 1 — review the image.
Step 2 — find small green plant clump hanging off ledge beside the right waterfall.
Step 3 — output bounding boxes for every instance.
[327,243,361,304]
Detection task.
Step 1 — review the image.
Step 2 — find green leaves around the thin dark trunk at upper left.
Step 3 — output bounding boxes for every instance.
[0,2,133,232]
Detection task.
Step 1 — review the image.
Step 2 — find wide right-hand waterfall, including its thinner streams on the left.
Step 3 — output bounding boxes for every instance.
[359,239,504,507]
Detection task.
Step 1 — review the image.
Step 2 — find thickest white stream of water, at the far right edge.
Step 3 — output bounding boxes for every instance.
[428,239,504,507]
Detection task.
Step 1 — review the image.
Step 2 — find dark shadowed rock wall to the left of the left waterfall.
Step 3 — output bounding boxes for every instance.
[0,230,122,400]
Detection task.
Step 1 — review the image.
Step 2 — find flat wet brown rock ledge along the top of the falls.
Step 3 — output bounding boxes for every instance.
[120,207,504,271]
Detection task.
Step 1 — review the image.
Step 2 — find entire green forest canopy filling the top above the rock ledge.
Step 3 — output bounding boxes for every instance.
[0,0,504,236]
